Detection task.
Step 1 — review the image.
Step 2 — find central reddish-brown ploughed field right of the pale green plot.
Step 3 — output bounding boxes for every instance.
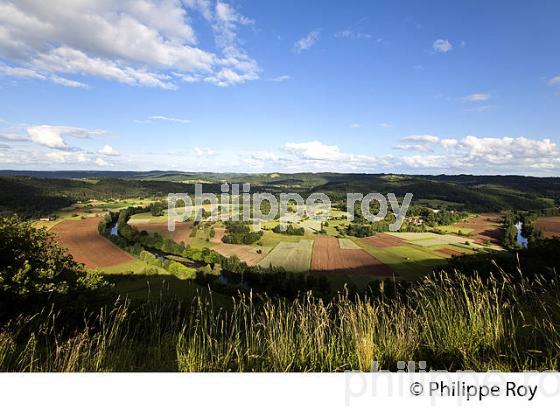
[311,236,398,277]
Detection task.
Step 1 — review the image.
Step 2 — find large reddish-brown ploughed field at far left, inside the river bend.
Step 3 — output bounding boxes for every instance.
[50,218,133,269]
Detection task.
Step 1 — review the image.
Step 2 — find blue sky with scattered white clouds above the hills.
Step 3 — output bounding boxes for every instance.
[0,0,560,176]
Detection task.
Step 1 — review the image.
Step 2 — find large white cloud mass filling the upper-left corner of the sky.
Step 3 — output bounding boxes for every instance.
[0,0,260,89]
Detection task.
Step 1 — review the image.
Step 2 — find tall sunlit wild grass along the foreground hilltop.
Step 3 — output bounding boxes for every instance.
[0,273,560,372]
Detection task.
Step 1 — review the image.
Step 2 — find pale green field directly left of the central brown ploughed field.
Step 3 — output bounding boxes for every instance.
[258,238,316,272]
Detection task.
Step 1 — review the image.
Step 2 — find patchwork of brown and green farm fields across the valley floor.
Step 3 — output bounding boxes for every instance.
[44,205,504,284]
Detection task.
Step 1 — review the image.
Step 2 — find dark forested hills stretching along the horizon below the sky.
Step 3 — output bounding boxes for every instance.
[0,171,560,215]
